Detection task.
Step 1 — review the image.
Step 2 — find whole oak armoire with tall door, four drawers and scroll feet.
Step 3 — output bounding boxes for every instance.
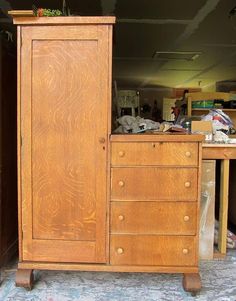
[14,17,202,292]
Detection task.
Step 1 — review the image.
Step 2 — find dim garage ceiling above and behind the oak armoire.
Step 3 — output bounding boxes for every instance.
[0,0,236,89]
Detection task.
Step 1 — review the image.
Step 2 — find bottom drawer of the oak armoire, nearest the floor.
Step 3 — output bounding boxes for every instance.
[110,234,197,266]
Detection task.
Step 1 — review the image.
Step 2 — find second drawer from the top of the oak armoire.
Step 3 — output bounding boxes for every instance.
[111,167,198,201]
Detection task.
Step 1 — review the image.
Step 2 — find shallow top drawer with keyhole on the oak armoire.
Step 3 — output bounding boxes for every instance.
[111,142,198,166]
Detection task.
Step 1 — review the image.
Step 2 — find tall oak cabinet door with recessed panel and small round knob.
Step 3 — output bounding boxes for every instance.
[19,25,111,263]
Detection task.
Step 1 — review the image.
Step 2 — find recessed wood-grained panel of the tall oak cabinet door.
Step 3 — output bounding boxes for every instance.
[32,41,98,240]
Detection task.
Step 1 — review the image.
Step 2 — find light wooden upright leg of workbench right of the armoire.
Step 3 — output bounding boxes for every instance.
[218,159,229,254]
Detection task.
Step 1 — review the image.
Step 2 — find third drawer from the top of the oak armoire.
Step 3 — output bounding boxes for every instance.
[110,202,197,235]
